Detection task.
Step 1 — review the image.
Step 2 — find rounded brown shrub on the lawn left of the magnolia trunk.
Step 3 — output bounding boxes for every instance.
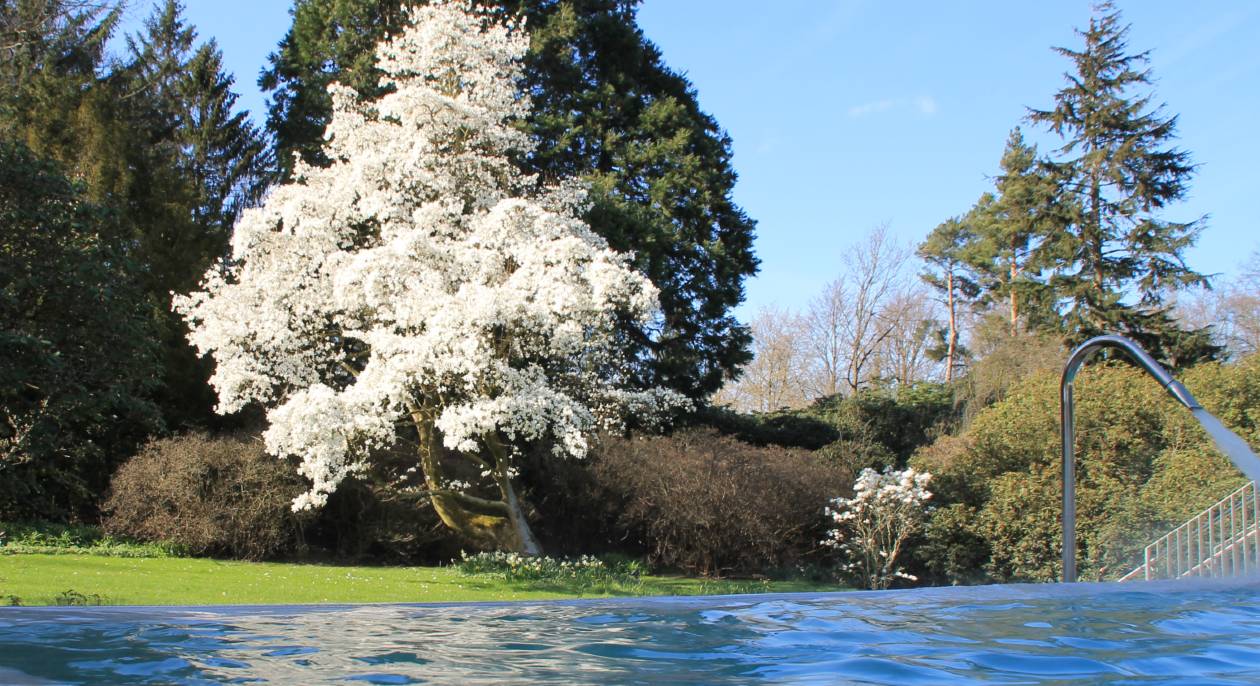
[105,434,306,560]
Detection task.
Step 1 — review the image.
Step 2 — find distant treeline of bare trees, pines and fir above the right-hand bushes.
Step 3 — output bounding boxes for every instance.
[716,4,1260,411]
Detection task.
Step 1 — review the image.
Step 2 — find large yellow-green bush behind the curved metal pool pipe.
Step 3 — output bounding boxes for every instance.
[912,356,1260,581]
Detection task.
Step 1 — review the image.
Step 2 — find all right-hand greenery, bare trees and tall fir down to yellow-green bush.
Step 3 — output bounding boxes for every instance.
[716,4,1260,584]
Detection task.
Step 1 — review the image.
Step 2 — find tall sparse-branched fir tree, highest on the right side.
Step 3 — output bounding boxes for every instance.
[1028,3,1215,363]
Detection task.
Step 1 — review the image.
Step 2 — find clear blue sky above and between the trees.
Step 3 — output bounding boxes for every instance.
[118,0,1260,318]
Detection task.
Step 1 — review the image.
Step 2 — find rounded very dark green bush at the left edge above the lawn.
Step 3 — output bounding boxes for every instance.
[0,142,161,520]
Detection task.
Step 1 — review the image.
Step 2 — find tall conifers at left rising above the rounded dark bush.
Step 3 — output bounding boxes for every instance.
[0,0,270,426]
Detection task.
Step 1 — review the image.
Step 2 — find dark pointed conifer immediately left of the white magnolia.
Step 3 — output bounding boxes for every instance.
[116,0,270,426]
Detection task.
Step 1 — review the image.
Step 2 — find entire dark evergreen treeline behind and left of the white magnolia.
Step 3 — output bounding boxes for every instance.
[0,0,757,550]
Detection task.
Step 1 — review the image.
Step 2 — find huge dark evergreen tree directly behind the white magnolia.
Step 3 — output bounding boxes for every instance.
[260,0,757,400]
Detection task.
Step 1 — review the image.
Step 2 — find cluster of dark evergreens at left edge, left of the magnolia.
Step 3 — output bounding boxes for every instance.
[0,0,272,520]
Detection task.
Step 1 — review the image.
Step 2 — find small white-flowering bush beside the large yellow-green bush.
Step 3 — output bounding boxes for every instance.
[823,467,932,590]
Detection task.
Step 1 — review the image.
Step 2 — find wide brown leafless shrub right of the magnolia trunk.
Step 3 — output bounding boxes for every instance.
[592,430,851,576]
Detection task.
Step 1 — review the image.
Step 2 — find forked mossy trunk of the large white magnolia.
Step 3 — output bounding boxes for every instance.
[411,409,542,555]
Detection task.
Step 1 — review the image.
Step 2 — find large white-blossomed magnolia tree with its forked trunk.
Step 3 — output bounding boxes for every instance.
[175,1,678,554]
